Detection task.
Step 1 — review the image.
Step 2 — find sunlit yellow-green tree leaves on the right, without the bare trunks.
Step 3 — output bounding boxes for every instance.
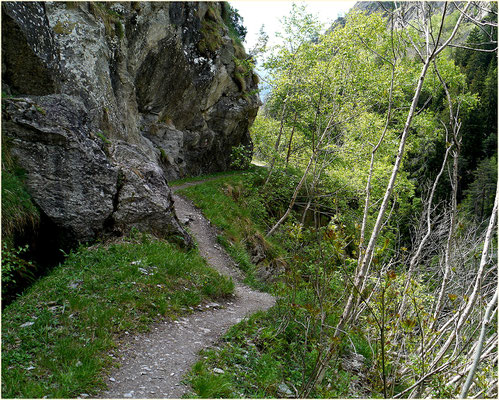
[242,2,497,395]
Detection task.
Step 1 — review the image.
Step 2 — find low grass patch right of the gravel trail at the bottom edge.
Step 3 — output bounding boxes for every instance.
[186,307,358,398]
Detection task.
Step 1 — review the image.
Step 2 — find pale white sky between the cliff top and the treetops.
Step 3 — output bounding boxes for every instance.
[229,0,356,50]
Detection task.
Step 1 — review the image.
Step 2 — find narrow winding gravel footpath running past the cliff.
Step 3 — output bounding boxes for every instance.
[99,177,275,398]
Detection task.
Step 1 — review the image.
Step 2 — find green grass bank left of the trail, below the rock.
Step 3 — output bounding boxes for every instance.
[2,235,234,398]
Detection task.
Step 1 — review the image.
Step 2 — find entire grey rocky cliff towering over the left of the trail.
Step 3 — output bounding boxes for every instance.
[2,2,259,245]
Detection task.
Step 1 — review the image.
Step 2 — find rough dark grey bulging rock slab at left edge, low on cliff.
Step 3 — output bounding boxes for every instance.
[2,95,118,240]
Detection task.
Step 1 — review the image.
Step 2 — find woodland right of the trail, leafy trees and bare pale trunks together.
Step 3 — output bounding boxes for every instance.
[242,2,497,397]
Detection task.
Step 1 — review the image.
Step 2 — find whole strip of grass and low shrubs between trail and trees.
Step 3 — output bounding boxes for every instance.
[180,167,372,398]
